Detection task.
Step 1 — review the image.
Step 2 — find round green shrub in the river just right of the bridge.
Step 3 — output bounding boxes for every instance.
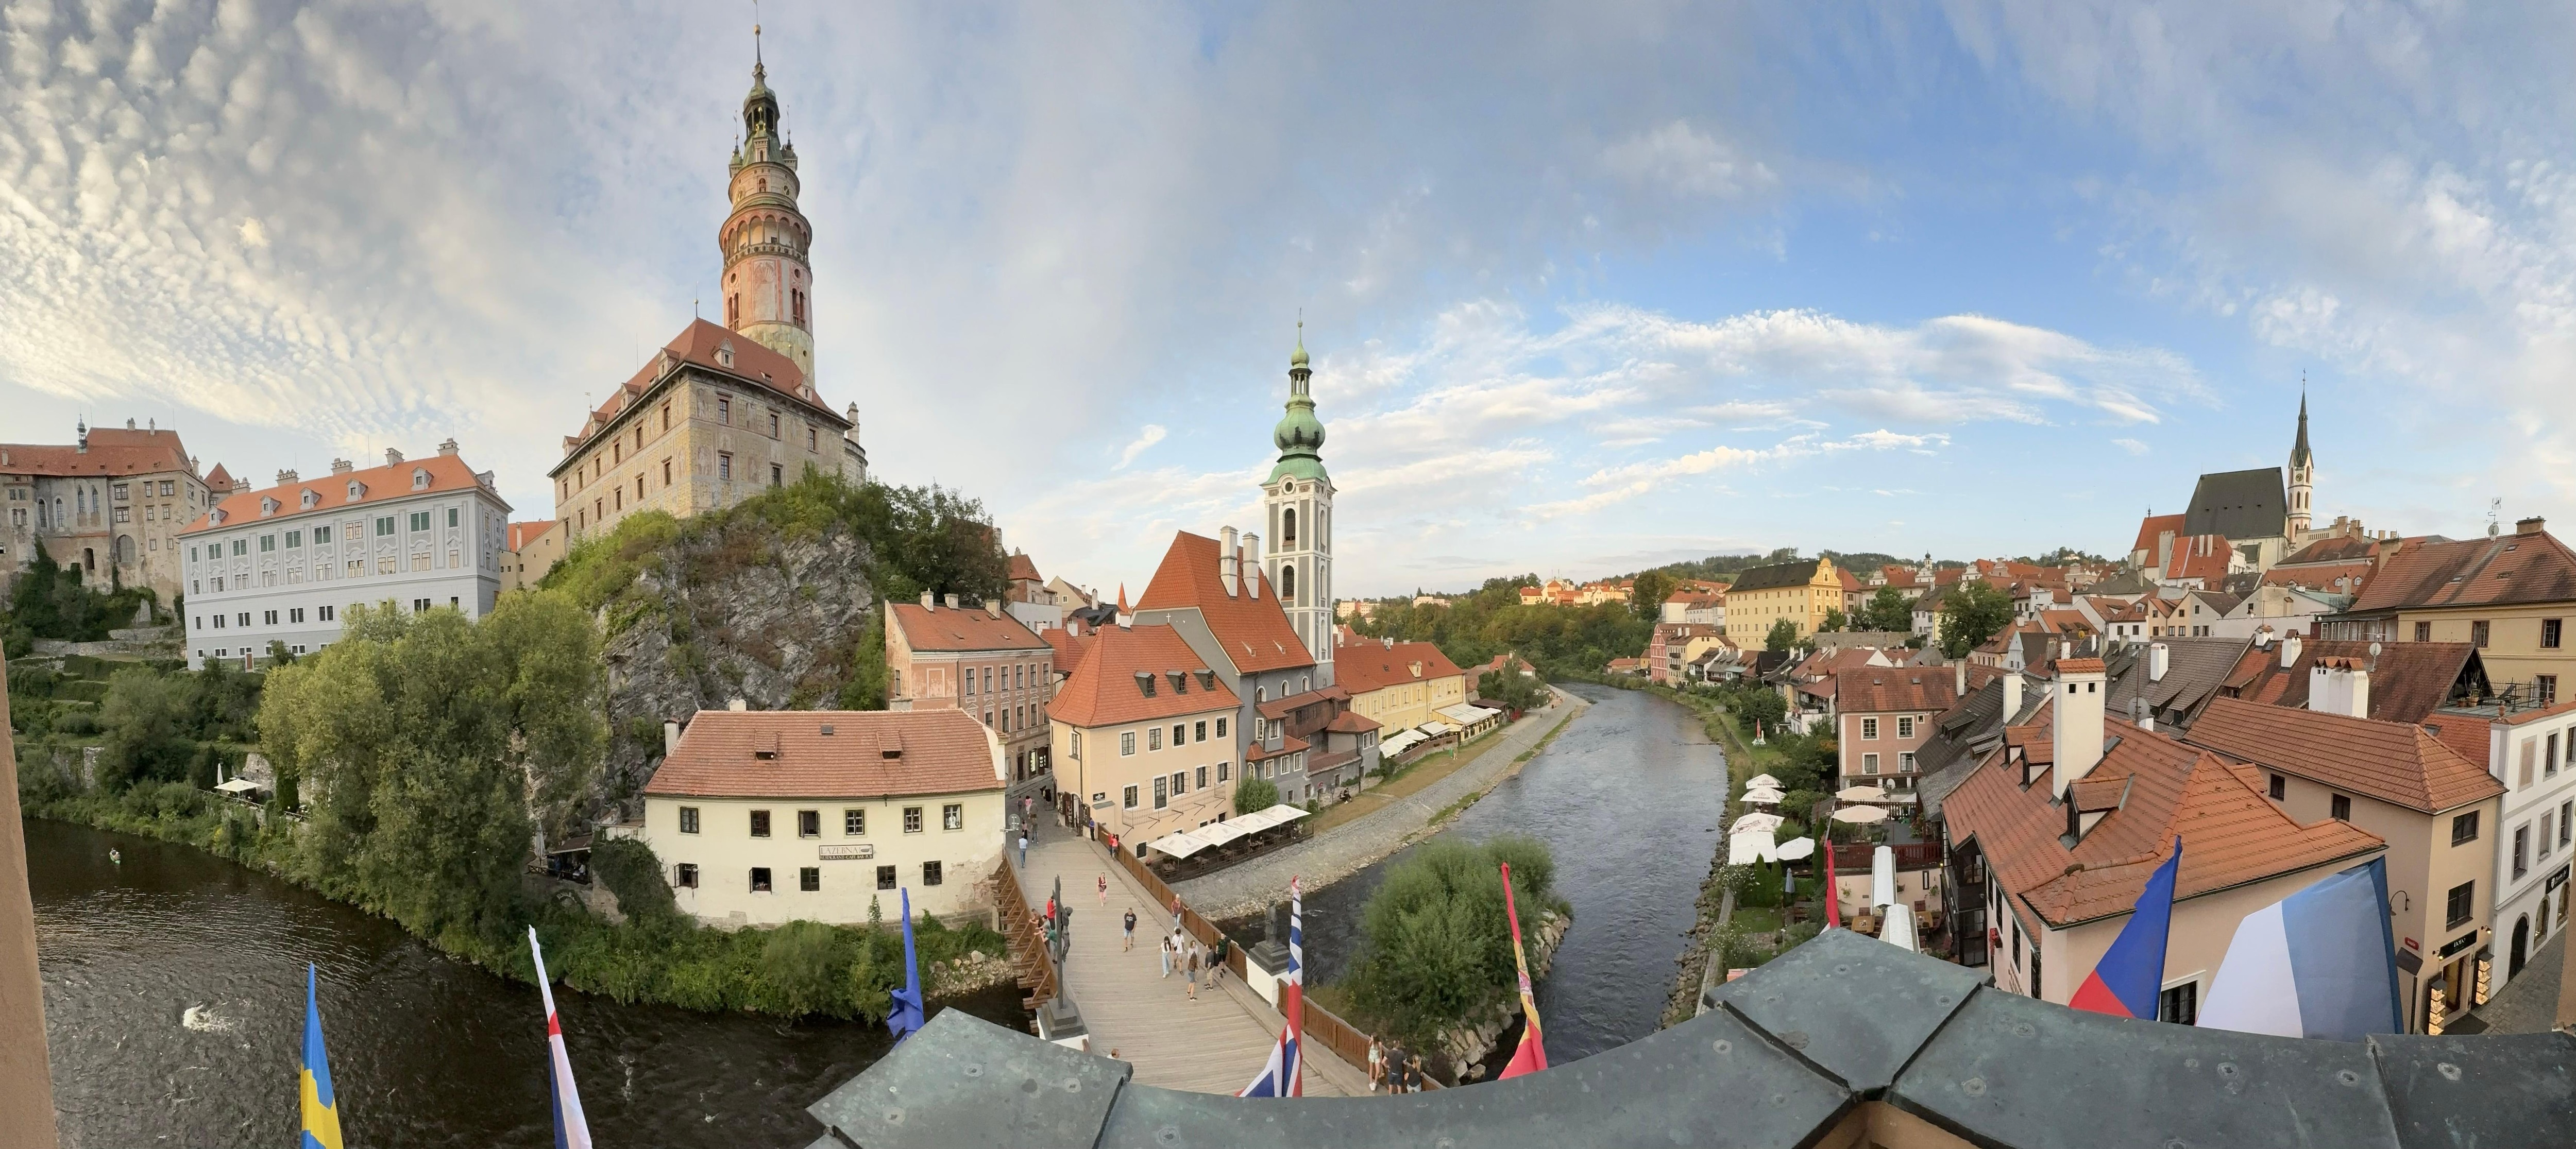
[1347,835,1571,1046]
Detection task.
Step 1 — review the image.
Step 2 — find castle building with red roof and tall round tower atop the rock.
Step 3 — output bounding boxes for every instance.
[549,42,868,541]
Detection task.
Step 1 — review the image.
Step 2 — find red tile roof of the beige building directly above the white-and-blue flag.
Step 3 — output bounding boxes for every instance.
[2184,698,2504,814]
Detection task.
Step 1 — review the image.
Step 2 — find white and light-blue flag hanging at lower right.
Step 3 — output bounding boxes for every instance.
[2200,858,2403,1041]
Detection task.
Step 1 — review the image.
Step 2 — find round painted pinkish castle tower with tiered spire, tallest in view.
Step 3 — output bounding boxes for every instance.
[716,28,814,384]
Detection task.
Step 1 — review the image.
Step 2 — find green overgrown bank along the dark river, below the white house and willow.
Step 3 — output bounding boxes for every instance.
[21,773,1007,1020]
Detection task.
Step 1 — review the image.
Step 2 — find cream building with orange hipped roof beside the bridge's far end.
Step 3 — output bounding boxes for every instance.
[1048,624,1242,858]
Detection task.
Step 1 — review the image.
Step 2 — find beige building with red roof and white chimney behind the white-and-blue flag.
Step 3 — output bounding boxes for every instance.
[2184,690,2504,1033]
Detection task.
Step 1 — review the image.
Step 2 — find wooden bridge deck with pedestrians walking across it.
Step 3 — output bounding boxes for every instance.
[1007,819,1368,1097]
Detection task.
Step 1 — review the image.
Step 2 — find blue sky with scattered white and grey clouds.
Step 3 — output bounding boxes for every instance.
[0,0,2576,595]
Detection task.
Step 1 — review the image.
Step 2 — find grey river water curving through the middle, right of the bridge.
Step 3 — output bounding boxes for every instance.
[1288,685,1726,1064]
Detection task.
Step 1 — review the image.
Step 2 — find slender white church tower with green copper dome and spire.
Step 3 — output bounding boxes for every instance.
[1262,322,1332,685]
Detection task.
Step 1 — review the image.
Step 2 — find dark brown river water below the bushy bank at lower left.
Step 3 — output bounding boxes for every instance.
[25,819,1025,1149]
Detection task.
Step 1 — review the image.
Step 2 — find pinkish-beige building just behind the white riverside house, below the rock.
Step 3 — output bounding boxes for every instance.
[886,590,1056,804]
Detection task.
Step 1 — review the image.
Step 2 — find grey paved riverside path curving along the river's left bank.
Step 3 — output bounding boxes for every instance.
[1172,691,1592,920]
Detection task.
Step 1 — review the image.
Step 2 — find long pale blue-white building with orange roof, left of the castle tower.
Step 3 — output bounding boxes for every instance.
[178,438,510,670]
